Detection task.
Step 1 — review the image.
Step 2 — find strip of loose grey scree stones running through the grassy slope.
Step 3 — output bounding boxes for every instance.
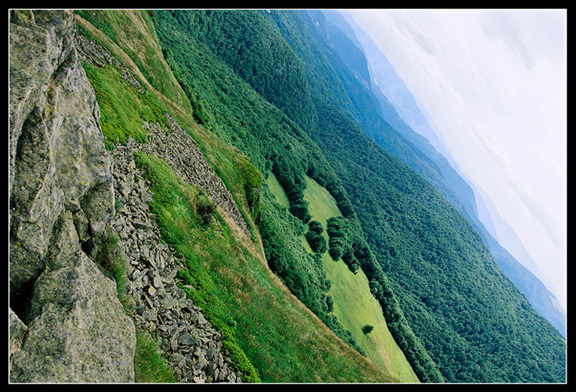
[78,31,250,383]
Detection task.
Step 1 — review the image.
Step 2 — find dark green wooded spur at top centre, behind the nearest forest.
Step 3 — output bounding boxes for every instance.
[162,10,314,133]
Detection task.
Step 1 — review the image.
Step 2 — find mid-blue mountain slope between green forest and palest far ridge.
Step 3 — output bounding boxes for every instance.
[306,11,476,222]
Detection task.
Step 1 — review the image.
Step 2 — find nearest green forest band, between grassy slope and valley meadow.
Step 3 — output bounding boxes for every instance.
[155,11,441,380]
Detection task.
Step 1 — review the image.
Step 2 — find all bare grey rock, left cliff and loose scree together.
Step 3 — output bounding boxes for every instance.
[9,10,250,383]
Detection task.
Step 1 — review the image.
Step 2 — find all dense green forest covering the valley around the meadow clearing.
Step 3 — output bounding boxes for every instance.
[154,11,566,382]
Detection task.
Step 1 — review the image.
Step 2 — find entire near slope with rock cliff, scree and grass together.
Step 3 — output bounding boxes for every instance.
[10,11,414,382]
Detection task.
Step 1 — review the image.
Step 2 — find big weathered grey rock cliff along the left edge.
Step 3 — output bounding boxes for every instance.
[9,10,136,382]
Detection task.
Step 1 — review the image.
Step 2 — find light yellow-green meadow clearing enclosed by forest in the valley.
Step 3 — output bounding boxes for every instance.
[302,177,419,382]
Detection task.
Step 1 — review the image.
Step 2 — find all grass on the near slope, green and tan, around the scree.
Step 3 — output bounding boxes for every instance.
[78,11,396,382]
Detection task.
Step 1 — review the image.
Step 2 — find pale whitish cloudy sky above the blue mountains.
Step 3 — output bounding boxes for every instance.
[350,10,567,308]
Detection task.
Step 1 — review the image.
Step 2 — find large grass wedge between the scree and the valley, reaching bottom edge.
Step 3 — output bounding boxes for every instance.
[136,154,394,382]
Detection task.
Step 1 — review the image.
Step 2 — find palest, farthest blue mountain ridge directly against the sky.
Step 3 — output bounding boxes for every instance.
[323,11,566,337]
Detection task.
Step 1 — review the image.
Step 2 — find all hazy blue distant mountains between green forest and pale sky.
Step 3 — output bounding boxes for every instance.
[316,10,566,337]
